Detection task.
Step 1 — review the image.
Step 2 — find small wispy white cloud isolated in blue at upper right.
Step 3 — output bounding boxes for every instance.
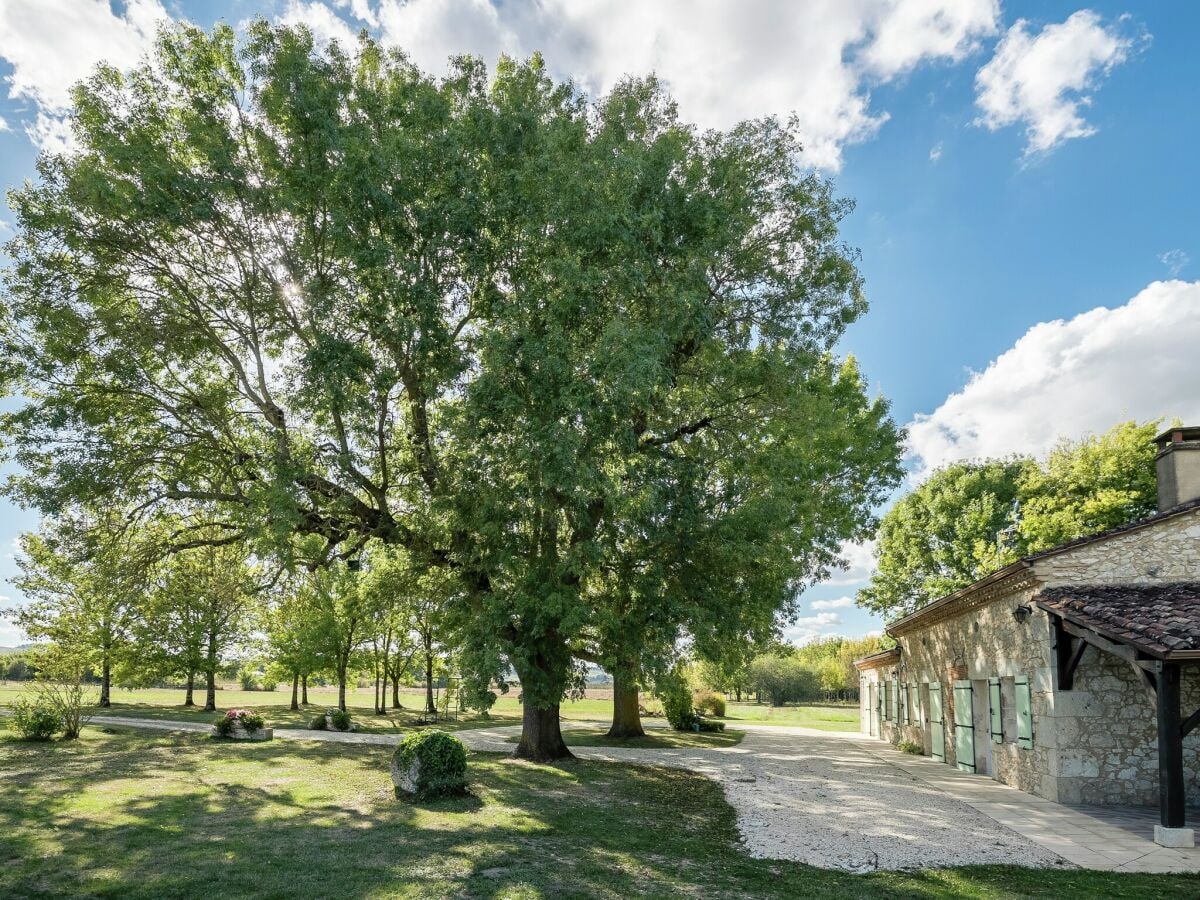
[976,10,1148,157]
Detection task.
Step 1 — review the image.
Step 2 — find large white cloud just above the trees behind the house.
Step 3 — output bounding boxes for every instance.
[908,281,1200,476]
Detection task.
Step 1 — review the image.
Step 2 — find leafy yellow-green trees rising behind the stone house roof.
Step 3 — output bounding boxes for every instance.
[858,420,1162,618]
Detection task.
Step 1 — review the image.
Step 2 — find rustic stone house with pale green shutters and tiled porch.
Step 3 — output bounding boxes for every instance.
[854,427,1200,846]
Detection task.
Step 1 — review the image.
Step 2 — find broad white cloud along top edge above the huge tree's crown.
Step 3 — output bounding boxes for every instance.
[378,0,998,169]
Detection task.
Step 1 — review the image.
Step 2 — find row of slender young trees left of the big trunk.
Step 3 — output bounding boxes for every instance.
[14,516,458,713]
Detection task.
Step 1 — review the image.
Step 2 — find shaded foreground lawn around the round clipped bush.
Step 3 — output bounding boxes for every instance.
[0,727,1196,900]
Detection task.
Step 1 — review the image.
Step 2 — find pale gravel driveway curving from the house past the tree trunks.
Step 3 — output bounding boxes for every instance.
[79,716,1068,872]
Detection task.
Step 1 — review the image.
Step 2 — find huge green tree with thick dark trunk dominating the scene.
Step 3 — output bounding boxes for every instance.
[0,23,896,758]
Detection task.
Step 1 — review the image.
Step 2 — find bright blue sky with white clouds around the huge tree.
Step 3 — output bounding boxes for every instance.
[0,0,1200,644]
